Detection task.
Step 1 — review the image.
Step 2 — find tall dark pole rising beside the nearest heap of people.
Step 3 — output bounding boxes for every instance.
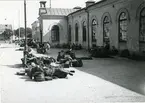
[24,0,27,66]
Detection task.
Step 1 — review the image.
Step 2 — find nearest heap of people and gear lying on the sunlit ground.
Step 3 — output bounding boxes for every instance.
[17,49,75,82]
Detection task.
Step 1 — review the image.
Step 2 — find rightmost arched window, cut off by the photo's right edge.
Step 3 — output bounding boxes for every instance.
[139,8,145,42]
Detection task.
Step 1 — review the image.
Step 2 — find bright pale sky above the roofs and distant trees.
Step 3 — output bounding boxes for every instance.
[0,0,98,29]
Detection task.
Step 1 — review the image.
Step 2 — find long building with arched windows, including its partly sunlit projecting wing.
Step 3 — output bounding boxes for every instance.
[33,0,145,52]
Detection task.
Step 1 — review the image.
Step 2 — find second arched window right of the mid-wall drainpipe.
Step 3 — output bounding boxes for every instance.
[103,16,110,42]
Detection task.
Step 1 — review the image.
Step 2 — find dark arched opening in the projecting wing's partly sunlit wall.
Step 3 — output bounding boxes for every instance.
[51,25,59,42]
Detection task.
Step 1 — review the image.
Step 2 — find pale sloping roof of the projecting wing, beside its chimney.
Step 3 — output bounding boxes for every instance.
[46,8,76,16]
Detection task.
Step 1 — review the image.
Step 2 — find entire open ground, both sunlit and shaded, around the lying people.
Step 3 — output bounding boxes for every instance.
[0,44,145,103]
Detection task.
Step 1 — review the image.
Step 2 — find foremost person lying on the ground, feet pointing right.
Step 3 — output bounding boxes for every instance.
[27,62,74,81]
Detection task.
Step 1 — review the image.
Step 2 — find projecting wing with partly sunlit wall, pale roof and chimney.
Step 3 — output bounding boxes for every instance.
[38,2,75,44]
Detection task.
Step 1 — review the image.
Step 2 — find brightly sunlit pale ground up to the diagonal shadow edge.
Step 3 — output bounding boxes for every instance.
[0,43,145,103]
